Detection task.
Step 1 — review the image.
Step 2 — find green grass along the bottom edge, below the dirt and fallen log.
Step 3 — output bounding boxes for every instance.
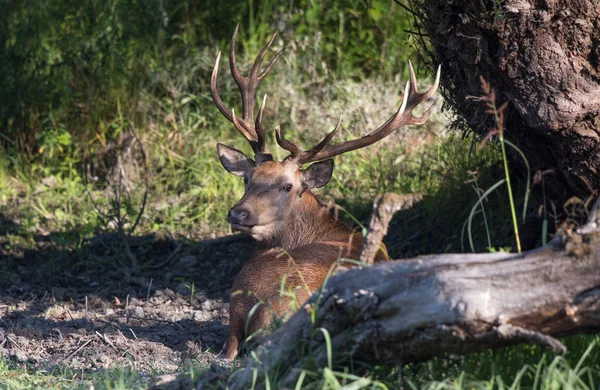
[0,336,600,390]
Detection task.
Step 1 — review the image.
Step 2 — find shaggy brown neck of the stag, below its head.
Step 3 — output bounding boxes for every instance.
[270,190,352,251]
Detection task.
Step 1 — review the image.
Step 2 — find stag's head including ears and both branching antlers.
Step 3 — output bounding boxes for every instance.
[210,26,440,241]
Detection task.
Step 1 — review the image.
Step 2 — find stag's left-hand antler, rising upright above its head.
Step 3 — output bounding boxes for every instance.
[210,24,285,155]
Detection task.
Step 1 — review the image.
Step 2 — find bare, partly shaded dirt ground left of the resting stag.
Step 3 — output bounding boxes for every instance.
[0,230,255,382]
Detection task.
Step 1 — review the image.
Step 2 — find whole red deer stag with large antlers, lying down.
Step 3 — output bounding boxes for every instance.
[210,27,440,359]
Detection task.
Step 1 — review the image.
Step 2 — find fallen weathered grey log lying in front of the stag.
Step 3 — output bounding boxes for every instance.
[220,200,600,389]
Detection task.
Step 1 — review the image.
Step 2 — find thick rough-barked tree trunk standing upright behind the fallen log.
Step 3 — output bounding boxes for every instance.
[409,0,600,204]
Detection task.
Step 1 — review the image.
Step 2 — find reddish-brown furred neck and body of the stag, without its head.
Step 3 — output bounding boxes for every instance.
[223,180,388,359]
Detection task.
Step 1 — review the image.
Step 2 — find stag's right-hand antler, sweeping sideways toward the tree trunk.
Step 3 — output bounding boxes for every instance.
[276,61,441,165]
